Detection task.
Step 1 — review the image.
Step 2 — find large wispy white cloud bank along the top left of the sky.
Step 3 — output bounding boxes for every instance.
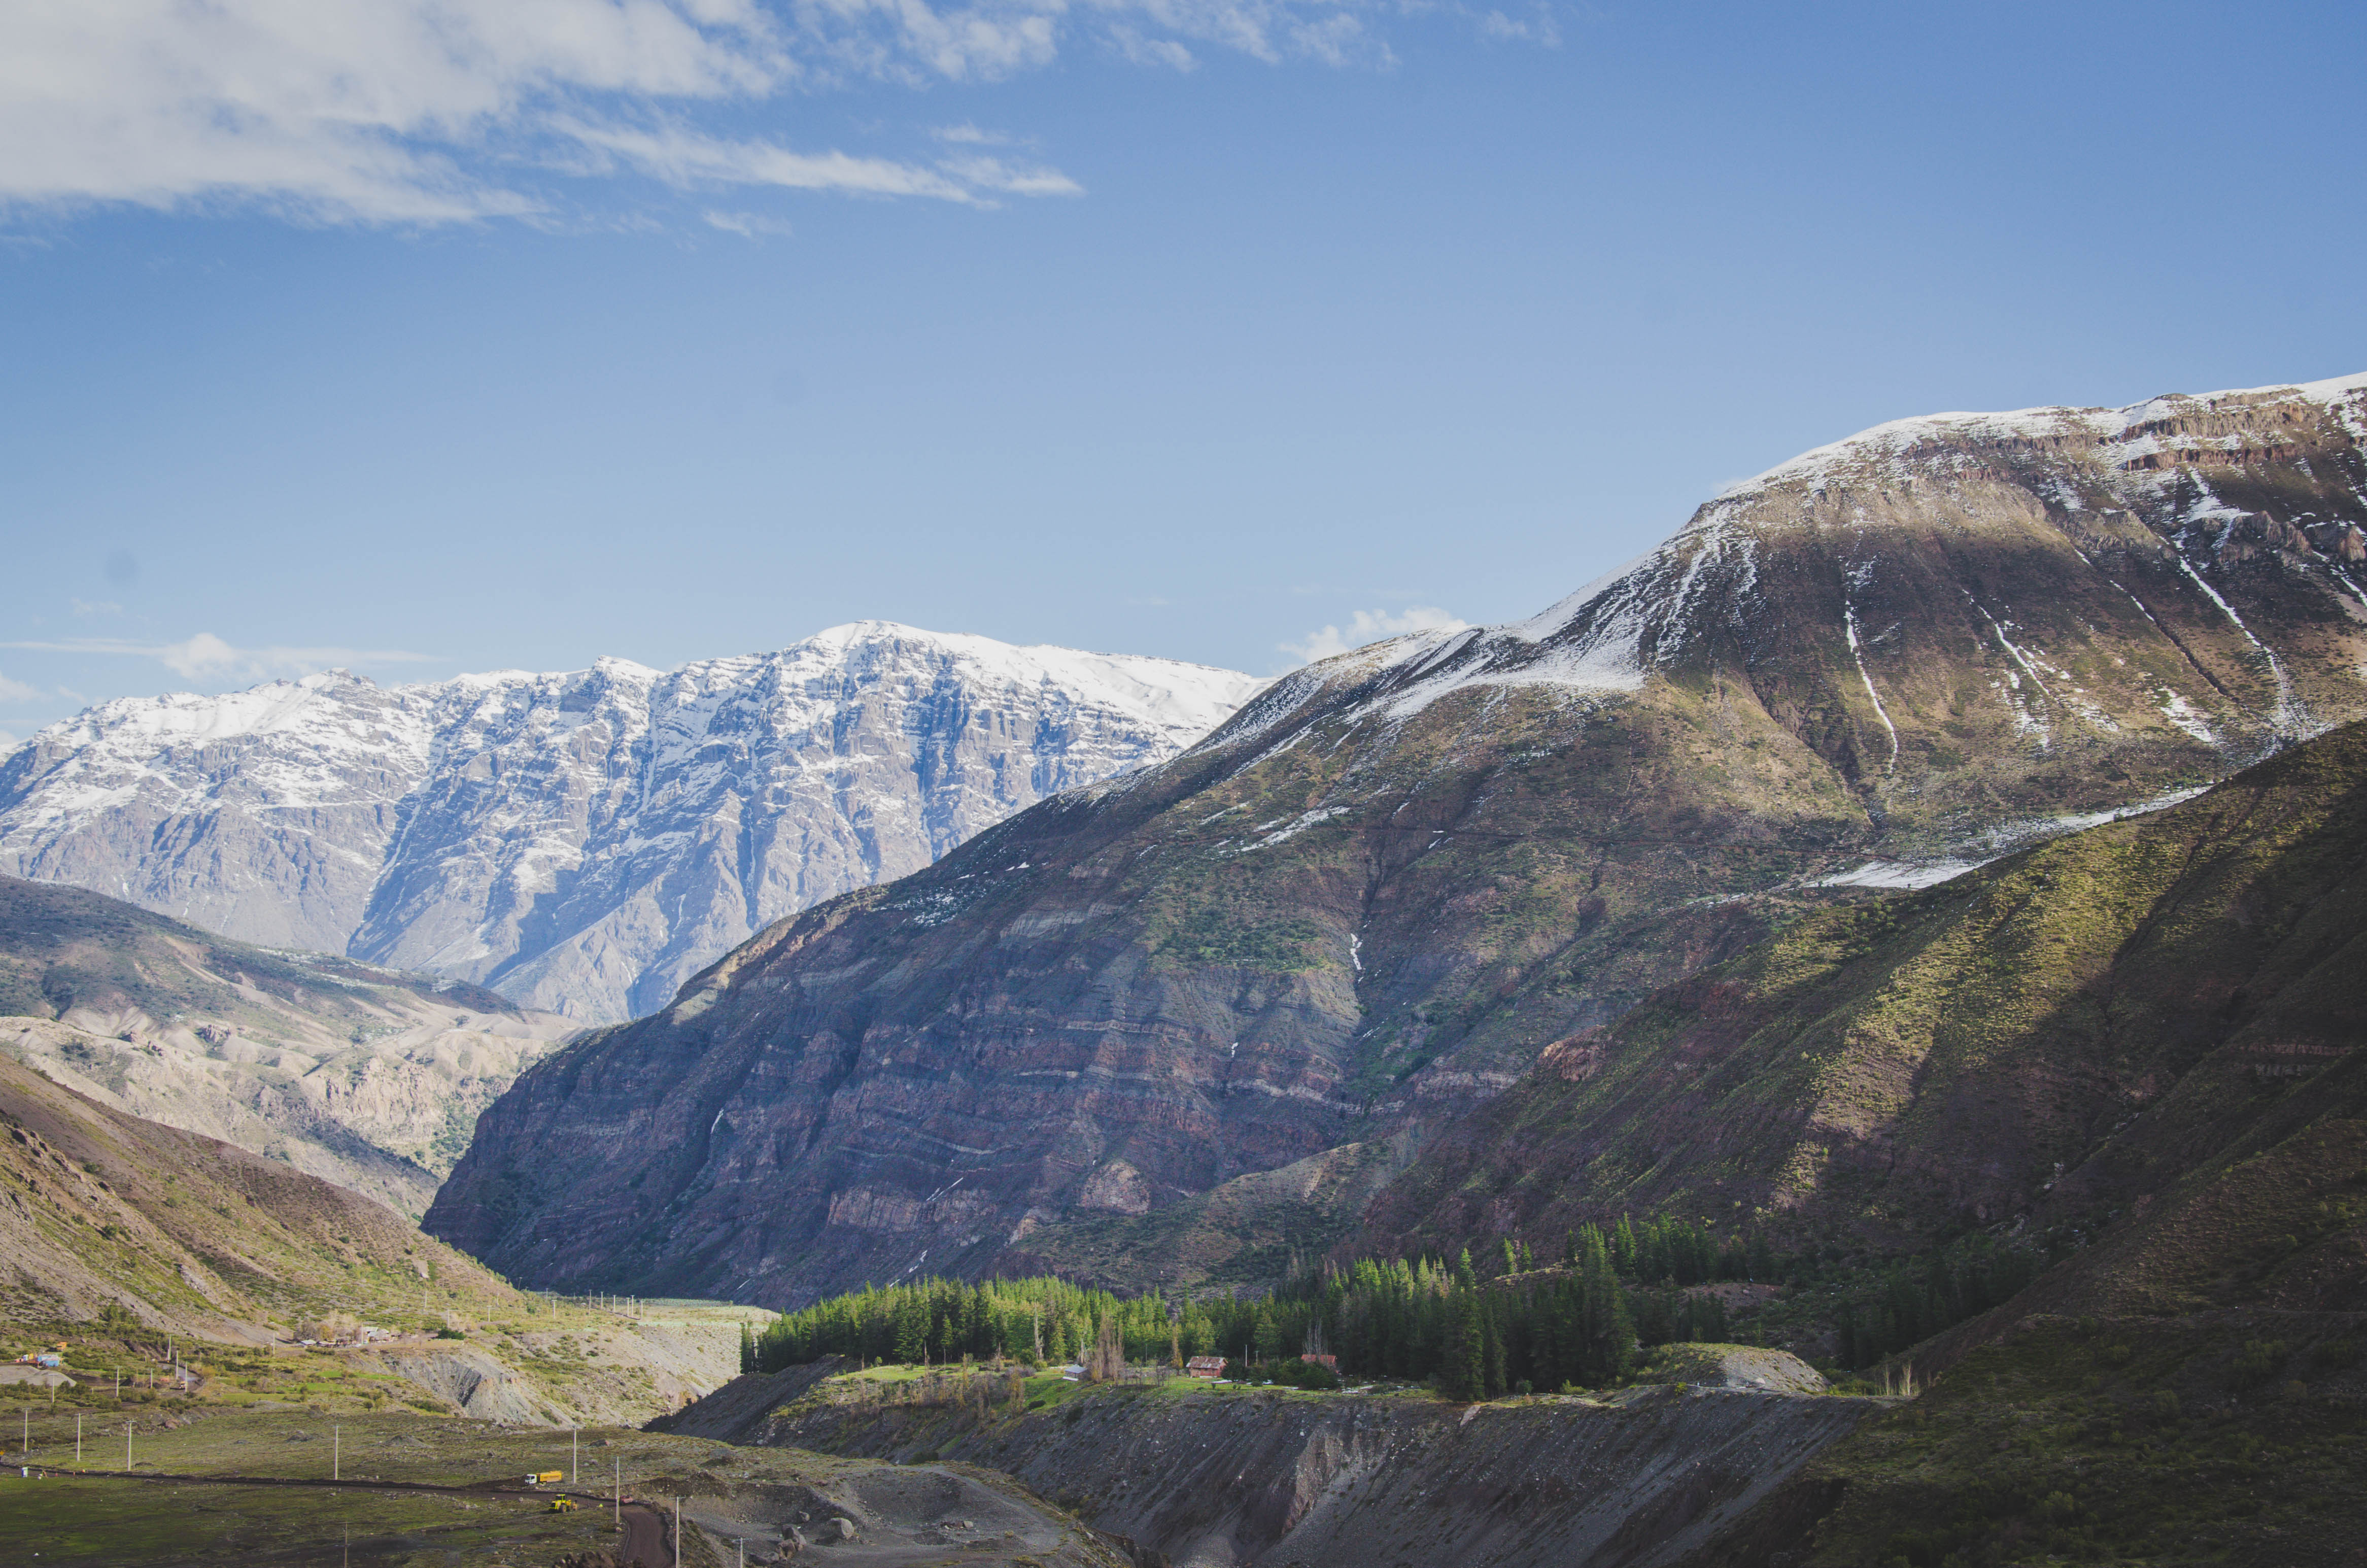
[0,0,1467,225]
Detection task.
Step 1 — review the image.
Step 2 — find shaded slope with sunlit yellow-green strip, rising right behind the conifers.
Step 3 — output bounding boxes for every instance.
[1356,725,2367,1253]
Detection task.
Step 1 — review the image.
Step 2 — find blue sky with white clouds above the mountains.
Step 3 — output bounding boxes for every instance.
[0,0,2367,746]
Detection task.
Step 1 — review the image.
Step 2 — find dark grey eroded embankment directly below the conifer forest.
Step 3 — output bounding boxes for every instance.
[710,1374,1877,1568]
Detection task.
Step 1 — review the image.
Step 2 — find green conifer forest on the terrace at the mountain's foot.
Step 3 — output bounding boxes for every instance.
[745,1217,2045,1400]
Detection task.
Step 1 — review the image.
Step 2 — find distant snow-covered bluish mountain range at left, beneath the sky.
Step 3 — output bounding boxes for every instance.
[0,621,1257,1021]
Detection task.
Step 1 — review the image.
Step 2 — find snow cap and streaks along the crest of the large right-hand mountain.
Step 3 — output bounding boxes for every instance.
[1212,372,2367,763]
